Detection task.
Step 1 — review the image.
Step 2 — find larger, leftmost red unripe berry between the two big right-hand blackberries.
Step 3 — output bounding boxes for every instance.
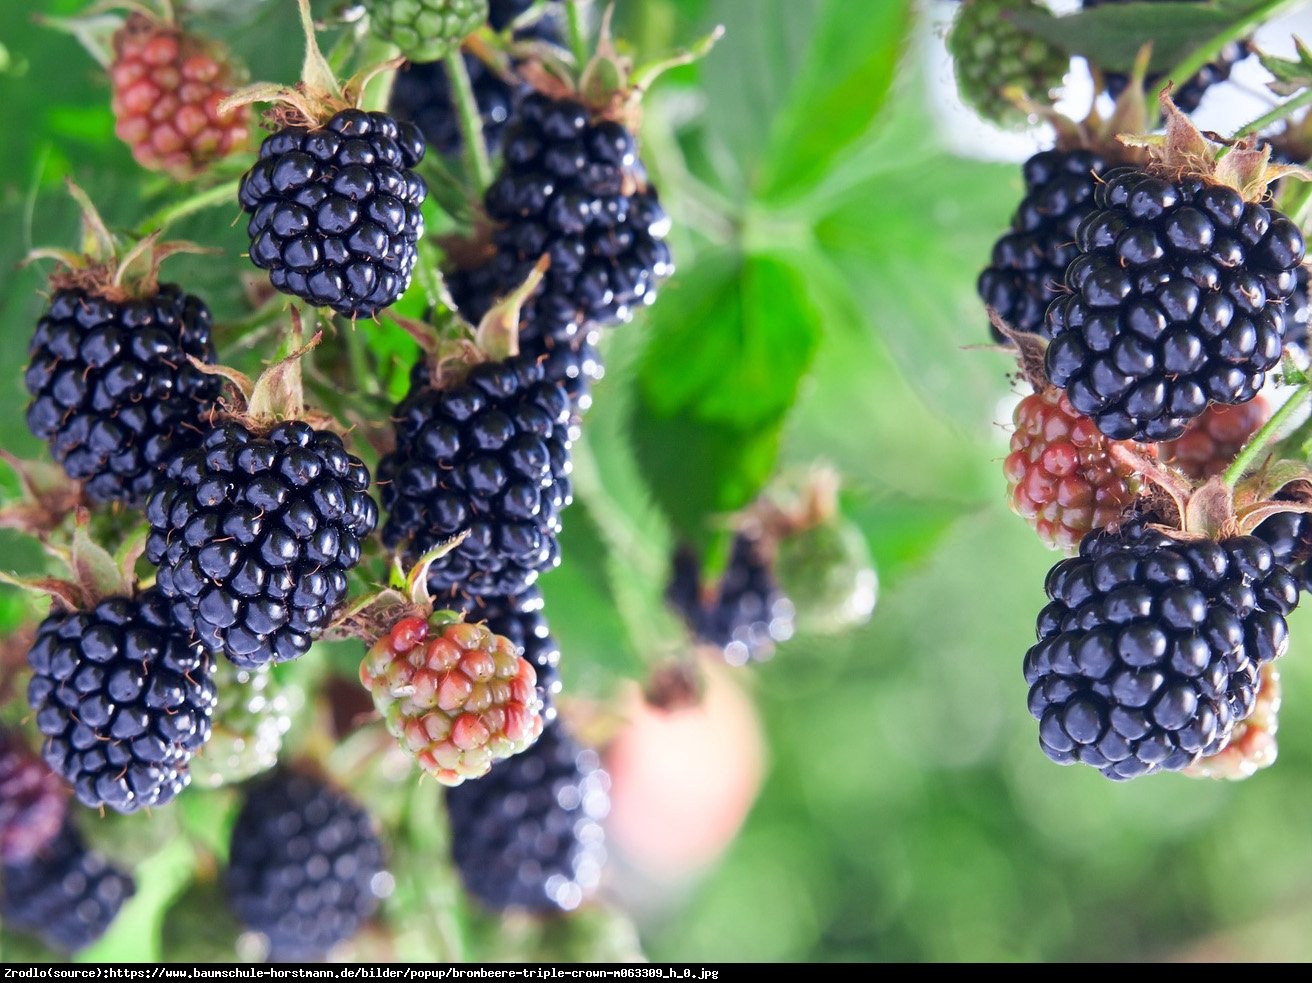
[1002,386,1139,550]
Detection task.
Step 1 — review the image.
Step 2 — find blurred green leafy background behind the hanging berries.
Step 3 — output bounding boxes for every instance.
[0,0,1312,961]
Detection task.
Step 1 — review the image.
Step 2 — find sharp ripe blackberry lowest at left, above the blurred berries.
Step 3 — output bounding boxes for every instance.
[28,588,215,812]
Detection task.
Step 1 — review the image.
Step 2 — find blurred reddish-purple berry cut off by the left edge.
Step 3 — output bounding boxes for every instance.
[0,730,68,864]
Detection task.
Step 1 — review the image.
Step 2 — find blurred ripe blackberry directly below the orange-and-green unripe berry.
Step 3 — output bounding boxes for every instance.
[446,721,610,912]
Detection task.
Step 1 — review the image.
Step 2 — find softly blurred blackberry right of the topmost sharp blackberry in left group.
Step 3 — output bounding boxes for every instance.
[449,93,674,341]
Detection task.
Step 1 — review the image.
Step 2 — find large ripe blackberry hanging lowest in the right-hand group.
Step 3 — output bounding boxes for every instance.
[1025,521,1299,780]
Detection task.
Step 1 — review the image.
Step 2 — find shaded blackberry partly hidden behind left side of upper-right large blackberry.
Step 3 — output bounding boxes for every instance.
[976,150,1107,343]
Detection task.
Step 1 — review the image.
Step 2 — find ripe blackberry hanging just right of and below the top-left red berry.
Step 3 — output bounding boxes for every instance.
[237,109,428,318]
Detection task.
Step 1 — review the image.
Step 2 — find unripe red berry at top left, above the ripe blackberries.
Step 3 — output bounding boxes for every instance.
[109,12,249,180]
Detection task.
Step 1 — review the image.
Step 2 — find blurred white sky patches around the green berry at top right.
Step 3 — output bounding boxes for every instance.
[918,0,1312,160]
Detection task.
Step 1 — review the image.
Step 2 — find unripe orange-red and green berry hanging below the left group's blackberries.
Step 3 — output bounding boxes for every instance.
[359,612,542,785]
